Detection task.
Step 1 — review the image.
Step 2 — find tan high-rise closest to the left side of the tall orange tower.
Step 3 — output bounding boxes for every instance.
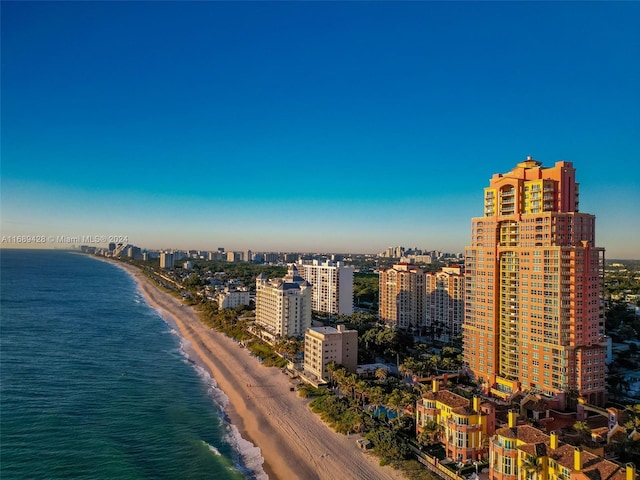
[425,267,464,342]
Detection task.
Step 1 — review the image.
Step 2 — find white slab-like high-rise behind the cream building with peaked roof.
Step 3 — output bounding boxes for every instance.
[298,260,354,315]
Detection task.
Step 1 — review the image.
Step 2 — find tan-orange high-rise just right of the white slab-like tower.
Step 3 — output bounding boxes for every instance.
[379,263,427,330]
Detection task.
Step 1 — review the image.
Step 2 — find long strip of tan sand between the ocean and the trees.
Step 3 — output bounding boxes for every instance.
[114,262,403,480]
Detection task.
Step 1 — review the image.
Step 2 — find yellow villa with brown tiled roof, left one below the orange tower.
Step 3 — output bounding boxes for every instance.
[416,380,495,462]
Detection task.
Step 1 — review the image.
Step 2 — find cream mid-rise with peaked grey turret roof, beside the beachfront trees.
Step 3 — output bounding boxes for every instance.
[256,265,311,337]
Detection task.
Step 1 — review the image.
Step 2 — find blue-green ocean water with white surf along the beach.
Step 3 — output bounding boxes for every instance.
[0,250,266,480]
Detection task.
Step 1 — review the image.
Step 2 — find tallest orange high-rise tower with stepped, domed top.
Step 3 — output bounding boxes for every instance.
[463,157,606,404]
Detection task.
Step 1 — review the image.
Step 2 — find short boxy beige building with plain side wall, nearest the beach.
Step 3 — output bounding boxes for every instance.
[304,325,358,380]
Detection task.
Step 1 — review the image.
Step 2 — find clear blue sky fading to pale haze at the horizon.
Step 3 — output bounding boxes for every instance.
[1,2,640,258]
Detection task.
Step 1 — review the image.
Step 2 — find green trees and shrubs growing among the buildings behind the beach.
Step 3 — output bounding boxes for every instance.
[105,253,640,479]
